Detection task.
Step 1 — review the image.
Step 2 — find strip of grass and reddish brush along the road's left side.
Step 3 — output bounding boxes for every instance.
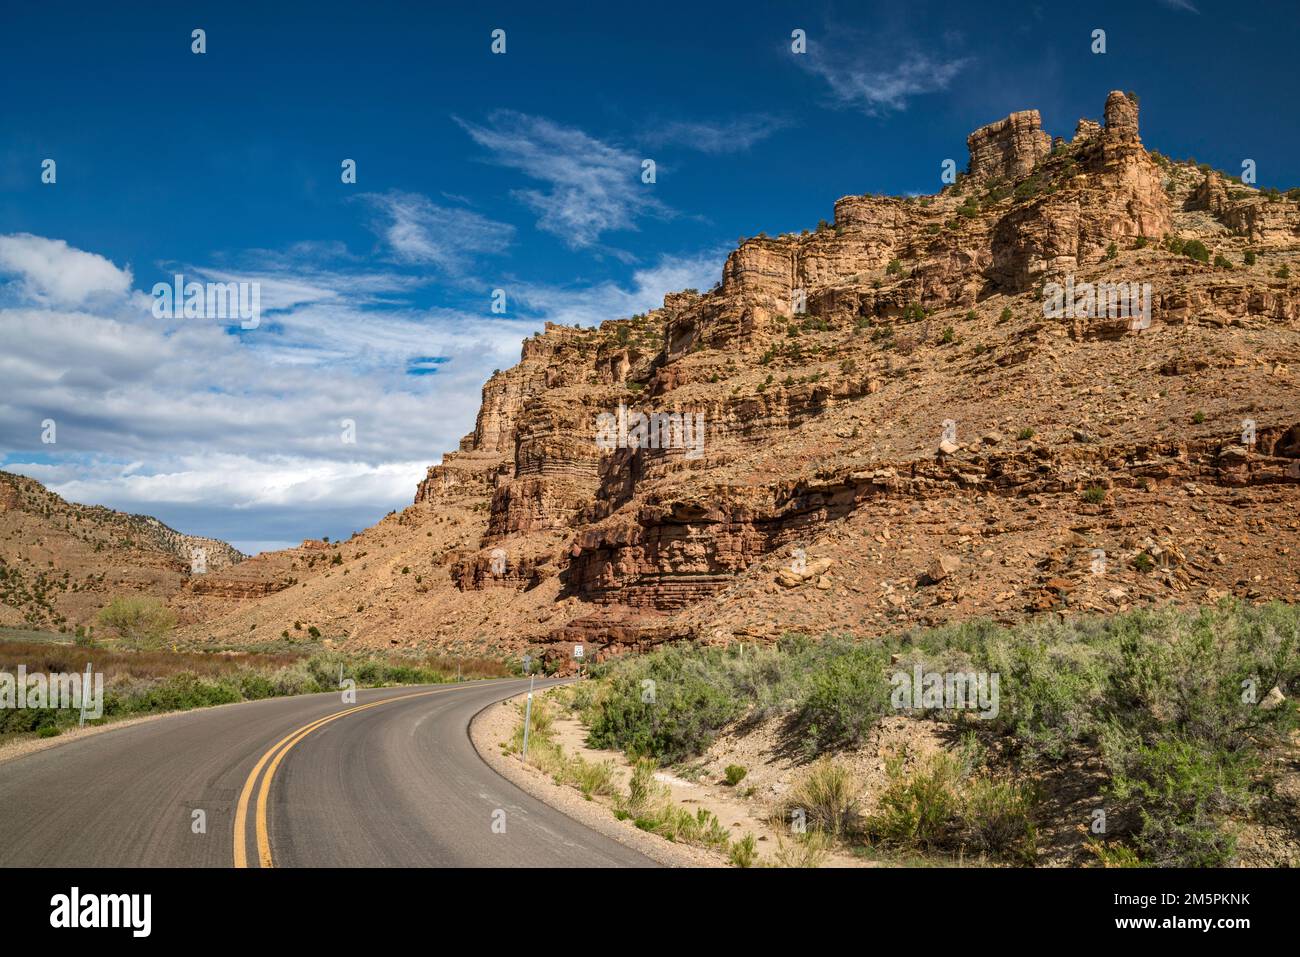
[0,641,514,744]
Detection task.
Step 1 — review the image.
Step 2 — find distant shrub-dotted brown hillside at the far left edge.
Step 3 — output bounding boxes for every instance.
[0,472,244,631]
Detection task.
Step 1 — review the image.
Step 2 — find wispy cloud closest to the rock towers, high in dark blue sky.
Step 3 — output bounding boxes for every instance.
[794,29,971,116]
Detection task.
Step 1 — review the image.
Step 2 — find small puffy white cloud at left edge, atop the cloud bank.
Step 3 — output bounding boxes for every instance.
[0,233,131,306]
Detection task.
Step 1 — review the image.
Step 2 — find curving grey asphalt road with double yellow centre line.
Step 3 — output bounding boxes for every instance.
[0,680,653,867]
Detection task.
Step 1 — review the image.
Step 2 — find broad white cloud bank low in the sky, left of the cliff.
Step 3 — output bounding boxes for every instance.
[0,231,724,550]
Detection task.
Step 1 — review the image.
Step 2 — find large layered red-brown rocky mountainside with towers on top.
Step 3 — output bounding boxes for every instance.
[178,92,1300,664]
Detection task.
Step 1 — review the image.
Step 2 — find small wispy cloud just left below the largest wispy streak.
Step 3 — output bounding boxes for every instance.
[360,191,515,276]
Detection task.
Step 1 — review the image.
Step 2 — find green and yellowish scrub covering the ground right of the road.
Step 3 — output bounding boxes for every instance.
[561,603,1300,866]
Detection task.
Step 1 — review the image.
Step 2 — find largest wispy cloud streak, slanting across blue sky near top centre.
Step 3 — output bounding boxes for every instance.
[454,109,673,248]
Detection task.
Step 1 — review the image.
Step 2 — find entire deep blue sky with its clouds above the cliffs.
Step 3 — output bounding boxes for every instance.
[0,0,1300,550]
